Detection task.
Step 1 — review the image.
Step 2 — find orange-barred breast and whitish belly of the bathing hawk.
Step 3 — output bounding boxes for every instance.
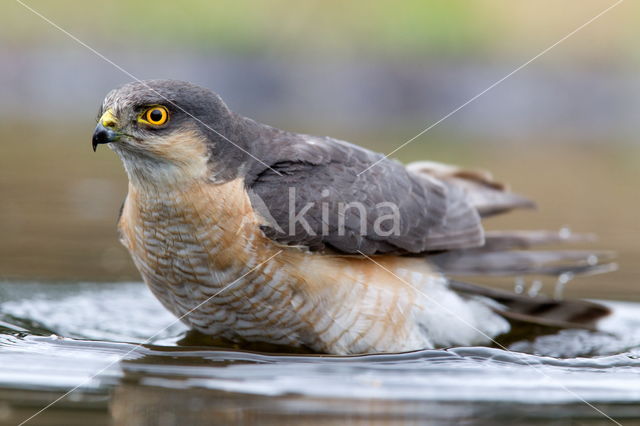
[119,180,502,354]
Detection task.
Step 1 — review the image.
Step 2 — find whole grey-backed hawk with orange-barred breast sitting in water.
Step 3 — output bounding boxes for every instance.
[92,80,608,355]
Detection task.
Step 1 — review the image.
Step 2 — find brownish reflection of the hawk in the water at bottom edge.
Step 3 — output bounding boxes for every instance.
[111,384,440,426]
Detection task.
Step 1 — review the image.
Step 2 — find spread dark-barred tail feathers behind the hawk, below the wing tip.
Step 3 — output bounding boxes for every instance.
[430,231,616,330]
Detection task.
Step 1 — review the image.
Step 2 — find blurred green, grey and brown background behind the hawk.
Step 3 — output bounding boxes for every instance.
[0,0,640,300]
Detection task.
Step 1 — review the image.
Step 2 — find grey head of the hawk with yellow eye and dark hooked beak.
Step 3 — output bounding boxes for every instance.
[92,80,248,185]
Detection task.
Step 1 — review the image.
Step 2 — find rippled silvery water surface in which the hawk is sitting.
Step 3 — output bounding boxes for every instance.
[0,283,640,425]
